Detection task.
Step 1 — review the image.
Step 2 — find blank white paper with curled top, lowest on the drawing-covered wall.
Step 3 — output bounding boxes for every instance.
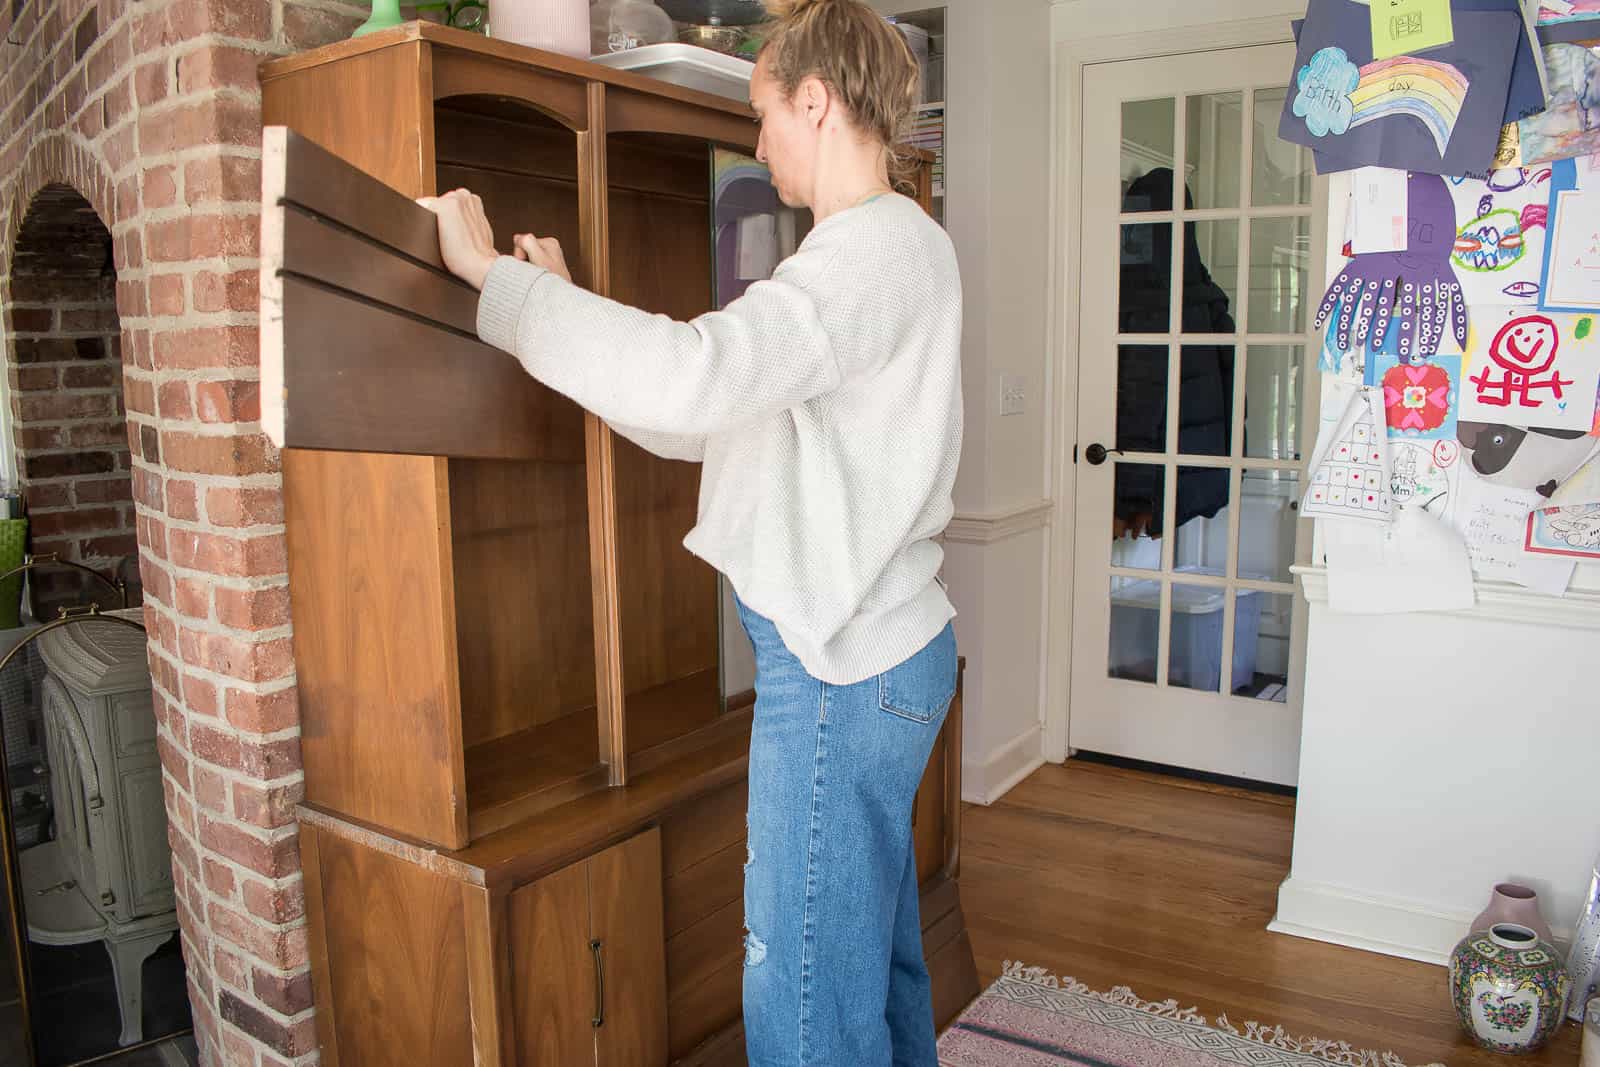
[1322,507,1475,614]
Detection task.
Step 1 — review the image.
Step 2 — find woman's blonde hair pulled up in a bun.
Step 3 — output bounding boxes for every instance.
[760,0,922,186]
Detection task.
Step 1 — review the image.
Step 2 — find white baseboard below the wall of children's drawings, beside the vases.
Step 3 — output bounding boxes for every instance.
[1267,875,1571,966]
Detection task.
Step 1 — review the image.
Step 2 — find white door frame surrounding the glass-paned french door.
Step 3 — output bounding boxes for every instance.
[1042,16,1328,763]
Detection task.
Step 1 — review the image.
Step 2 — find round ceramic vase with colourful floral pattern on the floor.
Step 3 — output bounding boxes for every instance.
[1450,923,1570,1053]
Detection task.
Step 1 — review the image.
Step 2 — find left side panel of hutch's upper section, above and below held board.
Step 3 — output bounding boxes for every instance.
[262,42,467,848]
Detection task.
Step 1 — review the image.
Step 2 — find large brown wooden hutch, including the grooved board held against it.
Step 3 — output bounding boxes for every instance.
[261,22,978,1067]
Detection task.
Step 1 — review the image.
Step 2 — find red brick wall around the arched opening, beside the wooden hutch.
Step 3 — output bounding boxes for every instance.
[0,0,377,1067]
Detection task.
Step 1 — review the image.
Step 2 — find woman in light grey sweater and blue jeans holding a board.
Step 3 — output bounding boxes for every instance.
[422,0,962,1067]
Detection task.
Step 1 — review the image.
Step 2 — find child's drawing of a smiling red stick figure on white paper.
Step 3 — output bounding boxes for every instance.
[1461,307,1600,434]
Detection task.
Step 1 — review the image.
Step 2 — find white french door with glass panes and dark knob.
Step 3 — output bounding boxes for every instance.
[1067,45,1326,784]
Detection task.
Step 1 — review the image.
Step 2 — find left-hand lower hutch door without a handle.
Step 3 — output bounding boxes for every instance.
[507,862,595,1067]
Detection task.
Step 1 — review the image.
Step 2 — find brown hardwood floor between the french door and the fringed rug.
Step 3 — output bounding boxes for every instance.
[962,761,1579,1067]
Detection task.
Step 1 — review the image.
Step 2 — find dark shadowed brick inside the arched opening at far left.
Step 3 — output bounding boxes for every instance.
[6,186,138,617]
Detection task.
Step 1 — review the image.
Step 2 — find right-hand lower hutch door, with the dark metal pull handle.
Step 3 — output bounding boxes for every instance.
[589,829,667,1067]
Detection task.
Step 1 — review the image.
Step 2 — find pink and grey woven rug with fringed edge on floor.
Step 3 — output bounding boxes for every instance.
[939,963,1443,1067]
